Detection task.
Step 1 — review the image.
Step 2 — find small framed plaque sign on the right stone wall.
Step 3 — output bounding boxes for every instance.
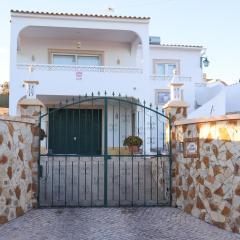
[183,138,199,158]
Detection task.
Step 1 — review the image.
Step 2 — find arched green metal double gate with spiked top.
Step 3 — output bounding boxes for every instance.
[38,94,171,207]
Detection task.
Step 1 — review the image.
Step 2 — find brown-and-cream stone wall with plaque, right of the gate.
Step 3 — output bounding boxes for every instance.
[173,115,240,232]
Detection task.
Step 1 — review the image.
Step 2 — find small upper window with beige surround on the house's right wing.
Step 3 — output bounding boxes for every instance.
[154,60,179,76]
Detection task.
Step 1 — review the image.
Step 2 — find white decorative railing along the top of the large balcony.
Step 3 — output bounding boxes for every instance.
[17,63,142,74]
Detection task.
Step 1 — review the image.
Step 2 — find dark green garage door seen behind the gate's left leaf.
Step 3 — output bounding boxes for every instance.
[49,109,102,155]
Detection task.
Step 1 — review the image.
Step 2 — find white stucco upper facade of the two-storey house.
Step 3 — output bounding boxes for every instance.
[9,11,203,115]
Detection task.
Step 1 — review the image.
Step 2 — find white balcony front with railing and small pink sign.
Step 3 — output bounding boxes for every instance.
[16,63,144,96]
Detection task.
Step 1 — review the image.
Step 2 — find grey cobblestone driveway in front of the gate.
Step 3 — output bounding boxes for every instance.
[0,208,240,240]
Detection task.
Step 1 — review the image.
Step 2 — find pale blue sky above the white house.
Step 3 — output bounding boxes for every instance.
[0,0,240,83]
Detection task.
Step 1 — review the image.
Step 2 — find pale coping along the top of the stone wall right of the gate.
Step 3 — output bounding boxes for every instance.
[174,114,240,126]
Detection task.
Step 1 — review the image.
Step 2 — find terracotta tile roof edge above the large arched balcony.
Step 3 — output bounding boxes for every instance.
[11,10,150,20]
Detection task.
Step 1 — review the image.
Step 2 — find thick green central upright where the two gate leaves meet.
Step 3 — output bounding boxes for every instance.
[104,92,108,207]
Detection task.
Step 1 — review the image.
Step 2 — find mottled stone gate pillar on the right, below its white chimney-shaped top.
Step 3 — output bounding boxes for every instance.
[163,100,188,207]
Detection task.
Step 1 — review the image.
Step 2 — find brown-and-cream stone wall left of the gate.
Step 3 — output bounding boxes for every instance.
[0,116,39,224]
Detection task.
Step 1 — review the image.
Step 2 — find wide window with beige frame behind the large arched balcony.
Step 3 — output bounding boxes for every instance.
[49,49,102,66]
